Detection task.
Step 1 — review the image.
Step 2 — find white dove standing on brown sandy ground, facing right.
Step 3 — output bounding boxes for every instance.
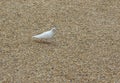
[33,27,56,39]
